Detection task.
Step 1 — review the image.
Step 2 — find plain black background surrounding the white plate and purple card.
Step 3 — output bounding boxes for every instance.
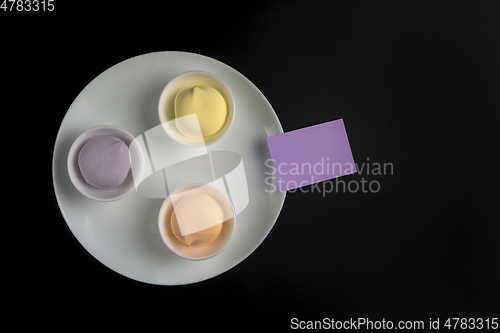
[4,0,500,331]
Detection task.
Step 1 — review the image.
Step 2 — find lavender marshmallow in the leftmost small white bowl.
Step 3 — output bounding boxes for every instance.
[78,135,130,189]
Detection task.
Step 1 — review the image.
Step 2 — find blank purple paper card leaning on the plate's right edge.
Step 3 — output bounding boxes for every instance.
[267,119,356,192]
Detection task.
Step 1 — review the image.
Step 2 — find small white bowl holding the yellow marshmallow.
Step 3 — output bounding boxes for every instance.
[158,71,234,147]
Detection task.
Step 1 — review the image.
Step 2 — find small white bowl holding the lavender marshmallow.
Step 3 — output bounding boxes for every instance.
[68,126,139,201]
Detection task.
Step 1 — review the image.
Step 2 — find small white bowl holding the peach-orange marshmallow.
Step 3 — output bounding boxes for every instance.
[158,184,236,260]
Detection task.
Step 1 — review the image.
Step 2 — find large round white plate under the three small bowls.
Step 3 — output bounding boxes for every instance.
[52,52,285,285]
